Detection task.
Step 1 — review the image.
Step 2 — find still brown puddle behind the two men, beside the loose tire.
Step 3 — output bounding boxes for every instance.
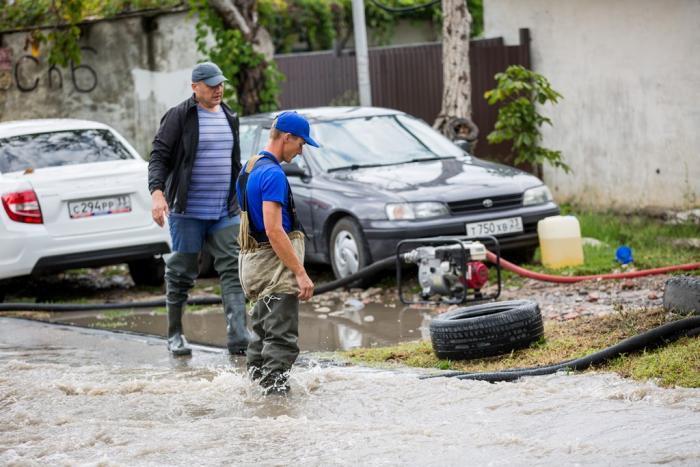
[45,303,430,352]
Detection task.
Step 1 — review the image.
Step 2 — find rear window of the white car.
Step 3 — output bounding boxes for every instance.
[0,129,133,173]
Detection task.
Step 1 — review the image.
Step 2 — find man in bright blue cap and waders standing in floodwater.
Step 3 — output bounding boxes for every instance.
[236,112,318,394]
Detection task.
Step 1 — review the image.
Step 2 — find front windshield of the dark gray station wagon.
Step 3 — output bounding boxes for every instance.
[307,115,464,170]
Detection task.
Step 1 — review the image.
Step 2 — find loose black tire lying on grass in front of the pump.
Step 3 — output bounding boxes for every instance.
[430,300,544,360]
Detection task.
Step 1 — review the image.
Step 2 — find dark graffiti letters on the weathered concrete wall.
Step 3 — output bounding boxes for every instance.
[0,47,97,93]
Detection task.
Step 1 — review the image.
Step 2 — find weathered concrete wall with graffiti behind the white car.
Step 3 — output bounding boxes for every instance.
[0,13,200,157]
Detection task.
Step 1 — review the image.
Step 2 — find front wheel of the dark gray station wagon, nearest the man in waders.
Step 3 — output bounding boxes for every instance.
[328,217,370,286]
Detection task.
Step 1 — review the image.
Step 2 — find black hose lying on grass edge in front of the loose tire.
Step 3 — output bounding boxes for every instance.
[421,316,700,383]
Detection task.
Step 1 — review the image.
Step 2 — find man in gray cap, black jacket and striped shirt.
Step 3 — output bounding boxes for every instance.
[148,62,248,356]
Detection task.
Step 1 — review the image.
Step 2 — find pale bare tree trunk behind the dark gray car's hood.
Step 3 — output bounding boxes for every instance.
[433,0,479,148]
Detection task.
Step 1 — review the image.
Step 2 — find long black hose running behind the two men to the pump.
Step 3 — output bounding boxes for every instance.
[0,256,396,312]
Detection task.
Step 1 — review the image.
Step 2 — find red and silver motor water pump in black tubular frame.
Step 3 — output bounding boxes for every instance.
[396,237,501,304]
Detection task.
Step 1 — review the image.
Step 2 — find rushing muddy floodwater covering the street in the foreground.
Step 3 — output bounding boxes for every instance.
[0,318,700,466]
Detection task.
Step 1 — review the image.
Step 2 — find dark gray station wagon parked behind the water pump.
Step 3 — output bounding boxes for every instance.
[241,107,559,278]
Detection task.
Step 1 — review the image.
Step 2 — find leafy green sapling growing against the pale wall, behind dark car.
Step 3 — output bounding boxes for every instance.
[484,65,571,172]
